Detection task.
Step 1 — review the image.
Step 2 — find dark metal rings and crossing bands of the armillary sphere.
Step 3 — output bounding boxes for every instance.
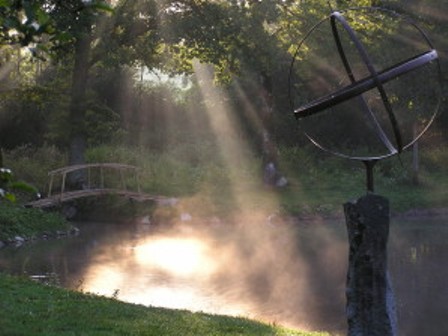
[289,8,440,161]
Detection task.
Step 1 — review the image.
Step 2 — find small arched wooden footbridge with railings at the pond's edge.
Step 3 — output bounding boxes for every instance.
[26,163,176,208]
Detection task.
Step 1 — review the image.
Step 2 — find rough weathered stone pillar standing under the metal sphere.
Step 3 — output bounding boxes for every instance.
[344,193,397,336]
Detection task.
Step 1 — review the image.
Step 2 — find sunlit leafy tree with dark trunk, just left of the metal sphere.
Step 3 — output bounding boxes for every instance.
[150,0,336,184]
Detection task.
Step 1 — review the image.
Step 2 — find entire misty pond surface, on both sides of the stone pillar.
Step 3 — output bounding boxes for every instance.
[0,218,448,336]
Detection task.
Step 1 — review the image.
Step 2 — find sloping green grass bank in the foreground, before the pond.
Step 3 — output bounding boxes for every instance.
[0,273,328,336]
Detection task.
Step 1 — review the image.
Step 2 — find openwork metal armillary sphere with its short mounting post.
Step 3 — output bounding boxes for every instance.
[289,7,441,191]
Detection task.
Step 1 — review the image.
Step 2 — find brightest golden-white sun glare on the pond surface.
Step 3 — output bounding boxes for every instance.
[82,232,251,316]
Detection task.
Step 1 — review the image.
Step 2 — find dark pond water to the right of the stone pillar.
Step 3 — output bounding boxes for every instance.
[389,220,448,336]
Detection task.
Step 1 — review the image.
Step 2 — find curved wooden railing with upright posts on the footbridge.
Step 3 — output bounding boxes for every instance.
[48,163,140,197]
